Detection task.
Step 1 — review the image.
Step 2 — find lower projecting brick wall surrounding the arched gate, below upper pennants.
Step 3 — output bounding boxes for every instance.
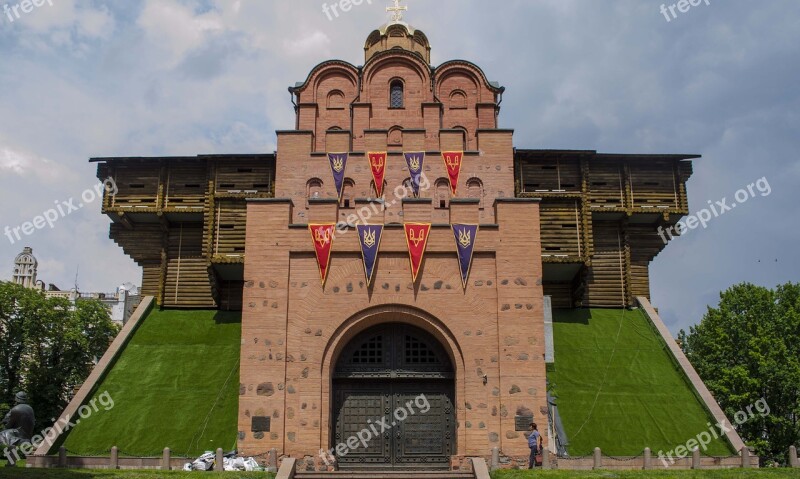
[239,200,546,457]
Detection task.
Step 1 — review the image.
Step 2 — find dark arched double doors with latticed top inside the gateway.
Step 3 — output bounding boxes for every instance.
[332,323,456,469]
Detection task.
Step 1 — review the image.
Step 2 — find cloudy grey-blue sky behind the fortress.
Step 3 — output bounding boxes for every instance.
[0,0,800,332]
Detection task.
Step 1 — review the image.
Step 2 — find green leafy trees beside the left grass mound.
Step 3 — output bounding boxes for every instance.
[0,282,118,429]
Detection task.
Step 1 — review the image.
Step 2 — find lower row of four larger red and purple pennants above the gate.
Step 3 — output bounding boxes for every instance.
[308,223,479,290]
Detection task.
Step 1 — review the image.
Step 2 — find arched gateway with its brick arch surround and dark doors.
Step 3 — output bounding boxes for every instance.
[321,305,464,469]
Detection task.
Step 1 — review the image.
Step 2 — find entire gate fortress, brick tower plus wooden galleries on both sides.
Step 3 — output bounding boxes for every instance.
[92,21,696,468]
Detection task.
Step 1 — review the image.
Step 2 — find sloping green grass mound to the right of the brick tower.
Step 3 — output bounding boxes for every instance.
[547,309,734,456]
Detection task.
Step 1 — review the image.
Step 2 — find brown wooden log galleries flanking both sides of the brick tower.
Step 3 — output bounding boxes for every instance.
[91,149,698,310]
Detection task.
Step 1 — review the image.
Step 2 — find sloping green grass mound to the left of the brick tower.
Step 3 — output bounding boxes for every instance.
[59,311,241,457]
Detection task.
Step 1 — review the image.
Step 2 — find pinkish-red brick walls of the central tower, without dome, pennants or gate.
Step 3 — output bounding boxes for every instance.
[239,30,546,464]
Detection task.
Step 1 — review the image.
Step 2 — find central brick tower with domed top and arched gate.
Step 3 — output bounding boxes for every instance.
[239,17,547,469]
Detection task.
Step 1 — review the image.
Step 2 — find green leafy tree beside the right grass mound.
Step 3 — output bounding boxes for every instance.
[678,283,800,464]
